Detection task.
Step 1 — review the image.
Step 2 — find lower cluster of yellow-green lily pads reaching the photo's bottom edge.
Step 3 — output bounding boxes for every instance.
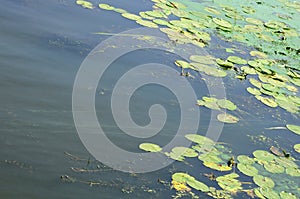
[139,132,300,199]
